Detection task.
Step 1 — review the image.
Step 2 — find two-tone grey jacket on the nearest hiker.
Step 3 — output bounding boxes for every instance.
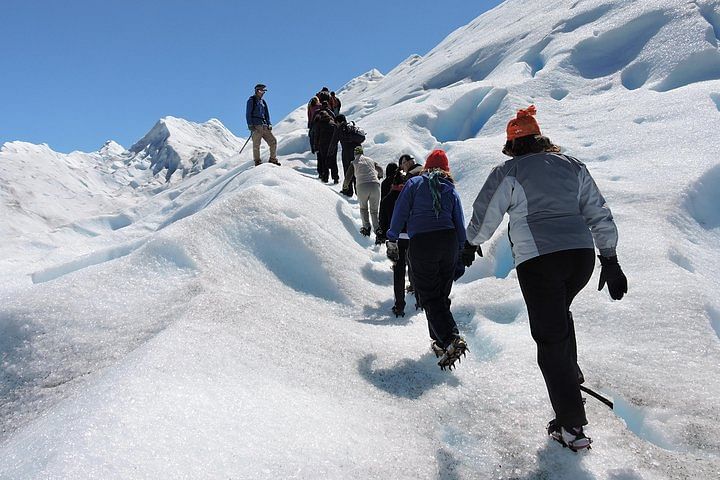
[467,153,618,266]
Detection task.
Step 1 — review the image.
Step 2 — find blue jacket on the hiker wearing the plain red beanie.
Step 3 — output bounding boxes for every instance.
[387,172,466,248]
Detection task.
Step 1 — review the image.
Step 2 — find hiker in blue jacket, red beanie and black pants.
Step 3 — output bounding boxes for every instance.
[387,150,467,370]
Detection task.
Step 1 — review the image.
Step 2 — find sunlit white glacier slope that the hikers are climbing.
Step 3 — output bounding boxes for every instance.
[0,0,720,480]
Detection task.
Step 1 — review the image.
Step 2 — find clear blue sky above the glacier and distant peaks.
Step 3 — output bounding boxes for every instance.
[0,0,501,152]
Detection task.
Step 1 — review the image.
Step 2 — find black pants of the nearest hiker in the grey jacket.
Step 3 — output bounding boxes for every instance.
[517,248,595,427]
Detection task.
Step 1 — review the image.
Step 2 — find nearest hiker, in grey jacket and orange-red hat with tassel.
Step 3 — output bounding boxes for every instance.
[464,105,627,451]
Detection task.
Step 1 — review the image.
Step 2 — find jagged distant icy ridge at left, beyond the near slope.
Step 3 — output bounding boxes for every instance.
[0,117,243,244]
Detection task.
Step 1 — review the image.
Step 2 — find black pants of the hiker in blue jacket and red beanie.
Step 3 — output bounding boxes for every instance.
[408,230,459,347]
